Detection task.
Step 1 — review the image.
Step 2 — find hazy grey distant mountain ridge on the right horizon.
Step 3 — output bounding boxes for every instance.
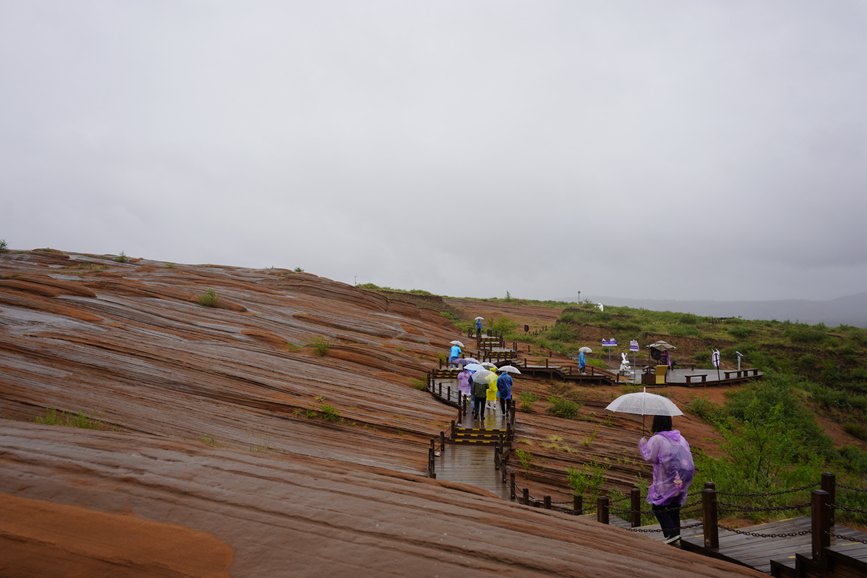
[587,292,867,327]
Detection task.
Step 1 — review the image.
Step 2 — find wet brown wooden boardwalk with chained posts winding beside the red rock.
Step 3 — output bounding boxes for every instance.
[429,340,867,578]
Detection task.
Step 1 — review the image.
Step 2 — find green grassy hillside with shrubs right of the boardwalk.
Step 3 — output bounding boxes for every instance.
[450,300,867,523]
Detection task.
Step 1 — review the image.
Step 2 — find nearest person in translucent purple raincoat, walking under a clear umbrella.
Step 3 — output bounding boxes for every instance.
[638,415,695,544]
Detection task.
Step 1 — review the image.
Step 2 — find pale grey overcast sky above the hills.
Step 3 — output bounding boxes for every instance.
[0,0,867,300]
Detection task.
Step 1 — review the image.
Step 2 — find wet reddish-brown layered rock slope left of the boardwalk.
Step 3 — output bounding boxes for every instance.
[0,251,757,577]
